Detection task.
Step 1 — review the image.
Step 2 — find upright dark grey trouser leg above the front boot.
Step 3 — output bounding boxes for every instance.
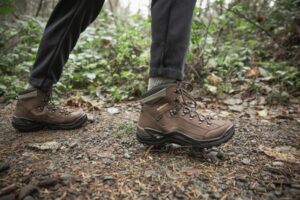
[150,0,196,80]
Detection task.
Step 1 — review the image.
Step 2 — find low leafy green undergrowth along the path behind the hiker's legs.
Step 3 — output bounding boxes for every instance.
[0,4,300,102]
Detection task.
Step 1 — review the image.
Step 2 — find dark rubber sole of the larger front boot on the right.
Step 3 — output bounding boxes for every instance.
[136,126,235,148]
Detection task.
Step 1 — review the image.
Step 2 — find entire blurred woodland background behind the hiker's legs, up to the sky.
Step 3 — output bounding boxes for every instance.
[0,0,300,103]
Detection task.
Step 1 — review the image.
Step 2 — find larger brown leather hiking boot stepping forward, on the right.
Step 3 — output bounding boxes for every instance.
[137,83,234,148]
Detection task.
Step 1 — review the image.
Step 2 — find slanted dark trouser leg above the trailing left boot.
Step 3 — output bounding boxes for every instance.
[29,0,105,91]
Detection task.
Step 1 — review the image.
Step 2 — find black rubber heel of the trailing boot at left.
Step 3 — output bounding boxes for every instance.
[12,117,44,132]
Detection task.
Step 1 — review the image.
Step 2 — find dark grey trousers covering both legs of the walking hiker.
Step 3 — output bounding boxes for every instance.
[29,0,196,91]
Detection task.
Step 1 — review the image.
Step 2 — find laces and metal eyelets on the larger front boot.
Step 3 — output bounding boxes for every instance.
[170,82,212,126]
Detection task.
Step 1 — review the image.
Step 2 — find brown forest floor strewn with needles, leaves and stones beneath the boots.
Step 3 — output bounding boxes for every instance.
[0,96,300,200]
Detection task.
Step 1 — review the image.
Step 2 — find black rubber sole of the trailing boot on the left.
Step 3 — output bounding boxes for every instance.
[12,115,87,132]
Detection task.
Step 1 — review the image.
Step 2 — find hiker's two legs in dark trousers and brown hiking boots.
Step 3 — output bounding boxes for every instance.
[12,0,234,147]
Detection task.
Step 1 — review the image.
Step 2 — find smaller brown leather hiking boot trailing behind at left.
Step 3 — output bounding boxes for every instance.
[12,89,87,132]
